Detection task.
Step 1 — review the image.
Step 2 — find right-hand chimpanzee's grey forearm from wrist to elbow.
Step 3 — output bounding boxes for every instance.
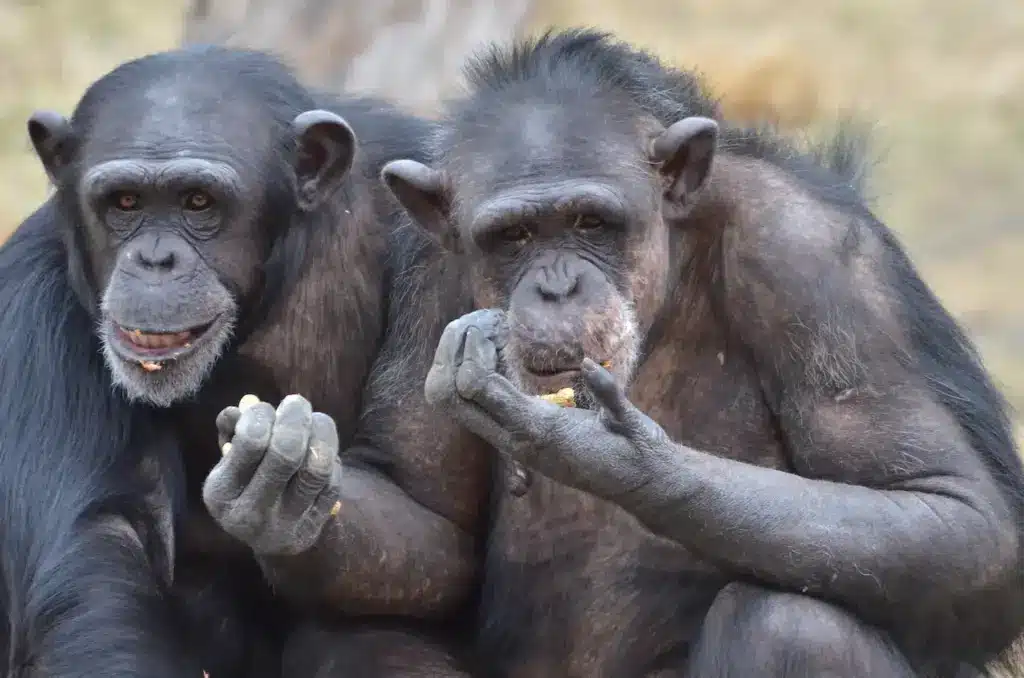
[617,443,1016,609]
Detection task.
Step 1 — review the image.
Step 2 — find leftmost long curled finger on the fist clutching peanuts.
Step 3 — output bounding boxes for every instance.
[203,402,274,502]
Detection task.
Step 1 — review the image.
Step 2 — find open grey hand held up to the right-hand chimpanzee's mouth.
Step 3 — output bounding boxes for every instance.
[425,310,674,501]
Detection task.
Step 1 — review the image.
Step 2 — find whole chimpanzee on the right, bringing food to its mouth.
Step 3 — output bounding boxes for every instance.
[382,31,1024,678]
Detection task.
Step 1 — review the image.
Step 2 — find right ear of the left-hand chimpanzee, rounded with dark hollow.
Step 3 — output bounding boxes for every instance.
[292,111,358,212]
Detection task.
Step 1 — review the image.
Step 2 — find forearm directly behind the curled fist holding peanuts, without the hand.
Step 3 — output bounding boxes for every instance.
[261,466,475,617]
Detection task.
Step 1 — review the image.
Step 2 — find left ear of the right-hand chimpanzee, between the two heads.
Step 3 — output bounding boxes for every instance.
[381,160,453,244]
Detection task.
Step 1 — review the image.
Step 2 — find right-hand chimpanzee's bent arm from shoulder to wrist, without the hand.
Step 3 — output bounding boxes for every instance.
[585,201,1021,630]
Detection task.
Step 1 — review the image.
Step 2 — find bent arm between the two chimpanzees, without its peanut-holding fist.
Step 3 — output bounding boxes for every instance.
[221,250,490,618]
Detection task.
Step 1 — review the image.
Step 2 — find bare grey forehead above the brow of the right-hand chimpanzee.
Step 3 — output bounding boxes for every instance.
[445,103,651,209]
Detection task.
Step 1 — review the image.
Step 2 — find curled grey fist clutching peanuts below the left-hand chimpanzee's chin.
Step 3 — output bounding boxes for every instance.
[203,395,342,555]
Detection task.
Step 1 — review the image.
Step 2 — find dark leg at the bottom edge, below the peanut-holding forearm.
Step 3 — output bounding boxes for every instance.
[283,624,471,678]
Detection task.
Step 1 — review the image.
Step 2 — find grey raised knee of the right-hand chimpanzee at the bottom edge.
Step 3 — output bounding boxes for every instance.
[686,584,916,678]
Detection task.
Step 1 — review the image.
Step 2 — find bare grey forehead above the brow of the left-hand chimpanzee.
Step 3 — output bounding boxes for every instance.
[75,77,273,167]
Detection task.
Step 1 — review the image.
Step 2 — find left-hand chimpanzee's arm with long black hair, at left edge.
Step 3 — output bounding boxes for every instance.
[0,200,202,678]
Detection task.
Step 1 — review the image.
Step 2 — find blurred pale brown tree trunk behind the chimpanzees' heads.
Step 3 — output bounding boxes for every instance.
[184,0,541,112]
